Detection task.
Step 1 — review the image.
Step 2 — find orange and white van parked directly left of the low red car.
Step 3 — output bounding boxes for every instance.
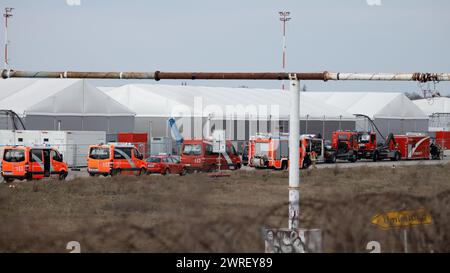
[87,143,147,176]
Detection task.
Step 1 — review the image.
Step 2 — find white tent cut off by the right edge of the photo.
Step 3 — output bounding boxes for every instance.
[414,97,450,131]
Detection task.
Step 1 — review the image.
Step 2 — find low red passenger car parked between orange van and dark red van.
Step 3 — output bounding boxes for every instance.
[147,155,187,176]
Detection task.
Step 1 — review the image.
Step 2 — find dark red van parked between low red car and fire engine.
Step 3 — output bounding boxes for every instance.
[181,139,242,172]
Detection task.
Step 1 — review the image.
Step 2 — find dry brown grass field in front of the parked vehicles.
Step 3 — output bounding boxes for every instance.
[0,163,450,252]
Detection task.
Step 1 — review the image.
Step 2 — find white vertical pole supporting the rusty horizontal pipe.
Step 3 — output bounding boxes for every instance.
[289,74,300,230]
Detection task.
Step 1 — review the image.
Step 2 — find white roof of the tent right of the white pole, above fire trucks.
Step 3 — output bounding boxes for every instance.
[305,92,428,119]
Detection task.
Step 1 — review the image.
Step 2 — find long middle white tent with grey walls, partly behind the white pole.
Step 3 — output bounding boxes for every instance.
[100,84,355,141]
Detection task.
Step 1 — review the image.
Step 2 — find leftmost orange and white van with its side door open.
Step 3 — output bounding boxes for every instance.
[2,146,68,182]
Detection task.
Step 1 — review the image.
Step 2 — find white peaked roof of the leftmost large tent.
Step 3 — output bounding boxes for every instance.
[0,79,135,116]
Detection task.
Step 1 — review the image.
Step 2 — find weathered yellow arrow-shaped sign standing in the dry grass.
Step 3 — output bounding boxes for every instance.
[371,209,433,229]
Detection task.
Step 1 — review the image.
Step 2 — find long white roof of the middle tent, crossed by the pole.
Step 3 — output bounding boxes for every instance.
[100,84,353,119]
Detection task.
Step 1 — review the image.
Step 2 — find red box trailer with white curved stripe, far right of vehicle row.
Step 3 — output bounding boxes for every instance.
[390,134,431,159]
